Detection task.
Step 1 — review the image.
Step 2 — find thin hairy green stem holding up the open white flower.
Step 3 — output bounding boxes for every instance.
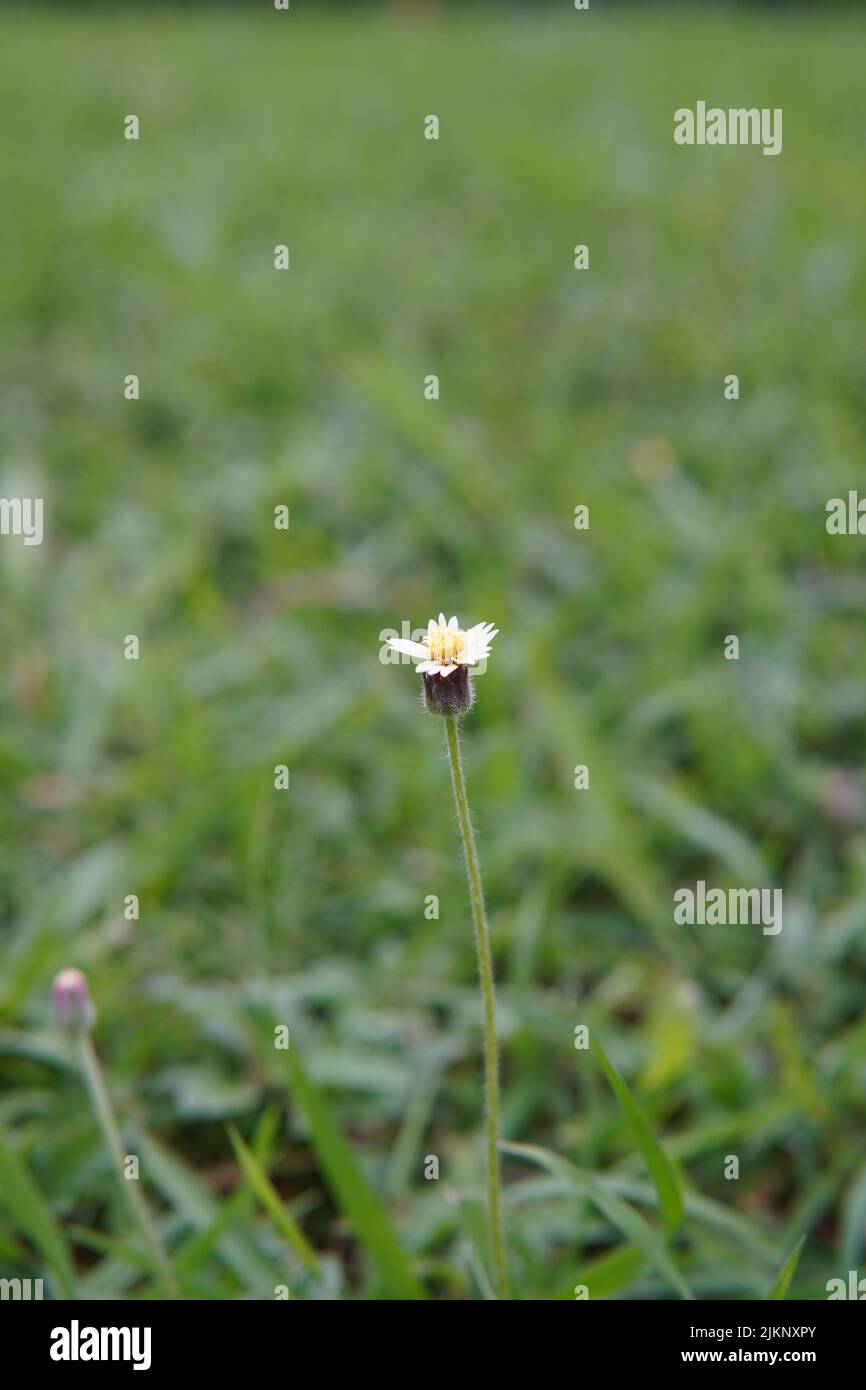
[445,716,509,1298]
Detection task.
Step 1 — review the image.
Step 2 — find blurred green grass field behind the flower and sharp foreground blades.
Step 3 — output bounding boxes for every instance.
[0,6,866,1298]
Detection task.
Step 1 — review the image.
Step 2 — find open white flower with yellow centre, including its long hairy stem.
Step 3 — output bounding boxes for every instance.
[389,613,509,1298]
